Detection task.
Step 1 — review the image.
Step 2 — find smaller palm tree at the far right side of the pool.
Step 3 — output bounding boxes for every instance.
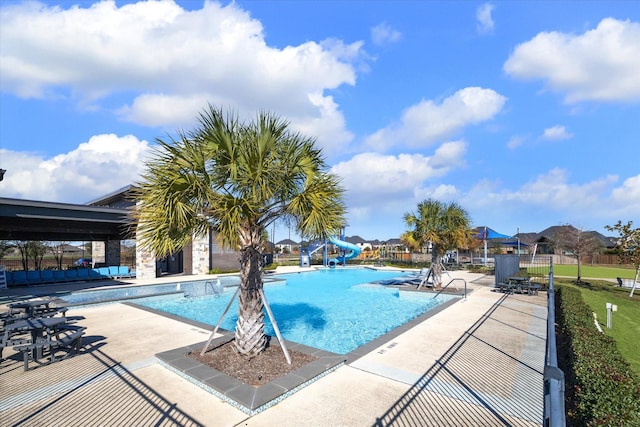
[404,199,471,287]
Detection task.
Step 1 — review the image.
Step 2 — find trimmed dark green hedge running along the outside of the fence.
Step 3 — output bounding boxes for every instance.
[556,286,640,427]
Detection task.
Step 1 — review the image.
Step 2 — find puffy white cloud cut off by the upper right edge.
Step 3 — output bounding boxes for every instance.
[504,18,640,103]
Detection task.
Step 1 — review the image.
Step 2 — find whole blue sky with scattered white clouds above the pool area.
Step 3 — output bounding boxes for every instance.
[0,0,640,241]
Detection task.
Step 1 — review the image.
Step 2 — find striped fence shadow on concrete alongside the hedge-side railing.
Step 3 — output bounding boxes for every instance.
[374,295,546,427]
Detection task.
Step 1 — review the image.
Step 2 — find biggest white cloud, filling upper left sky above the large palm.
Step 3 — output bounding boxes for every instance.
[0,1,360,150]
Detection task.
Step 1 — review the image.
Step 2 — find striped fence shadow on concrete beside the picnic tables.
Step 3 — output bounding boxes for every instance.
[0,336,202,426]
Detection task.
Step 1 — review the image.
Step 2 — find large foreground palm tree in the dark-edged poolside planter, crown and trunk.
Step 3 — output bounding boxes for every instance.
[135,105,345,358]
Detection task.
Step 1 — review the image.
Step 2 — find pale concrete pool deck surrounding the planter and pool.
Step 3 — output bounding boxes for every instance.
[0,271,547,426]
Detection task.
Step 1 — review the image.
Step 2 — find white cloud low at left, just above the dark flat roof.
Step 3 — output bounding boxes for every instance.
[0,134,149,203]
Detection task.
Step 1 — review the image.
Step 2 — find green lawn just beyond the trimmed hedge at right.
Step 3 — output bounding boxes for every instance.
[558,279,640,375]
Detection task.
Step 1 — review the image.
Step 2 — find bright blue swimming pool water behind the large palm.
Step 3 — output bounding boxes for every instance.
[136,269,455,354]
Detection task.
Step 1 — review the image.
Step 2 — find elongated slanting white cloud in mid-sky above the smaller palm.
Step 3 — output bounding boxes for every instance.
[366,87,507,151]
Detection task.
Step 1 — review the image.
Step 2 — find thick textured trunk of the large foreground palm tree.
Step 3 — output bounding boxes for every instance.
[234,231,267,359]
